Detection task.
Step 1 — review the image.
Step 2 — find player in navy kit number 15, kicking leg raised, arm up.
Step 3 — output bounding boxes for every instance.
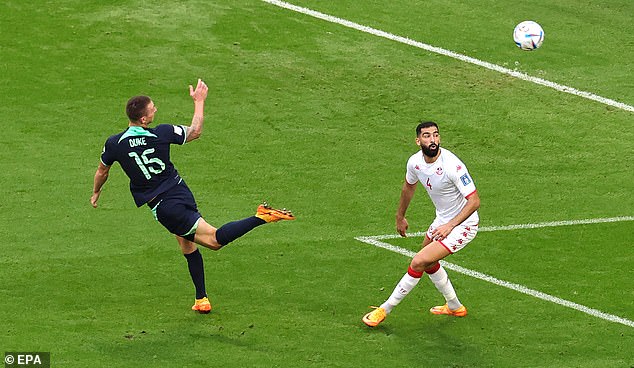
[90,79,295,313]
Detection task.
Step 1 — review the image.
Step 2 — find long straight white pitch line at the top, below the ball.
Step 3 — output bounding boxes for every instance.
[262,0,634,112]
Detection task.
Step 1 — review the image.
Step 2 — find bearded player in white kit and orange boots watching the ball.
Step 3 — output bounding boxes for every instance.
[362,121,480,327]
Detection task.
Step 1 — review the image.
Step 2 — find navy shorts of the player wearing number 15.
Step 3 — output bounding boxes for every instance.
[147,181,202,241]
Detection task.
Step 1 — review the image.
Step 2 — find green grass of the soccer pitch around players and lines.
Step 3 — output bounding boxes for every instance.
[0,0,634,367]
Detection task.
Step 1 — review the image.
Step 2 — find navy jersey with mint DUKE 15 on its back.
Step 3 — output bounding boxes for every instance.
[101,124,187,207]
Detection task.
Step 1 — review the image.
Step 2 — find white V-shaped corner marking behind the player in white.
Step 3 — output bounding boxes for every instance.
[355,216,634,327]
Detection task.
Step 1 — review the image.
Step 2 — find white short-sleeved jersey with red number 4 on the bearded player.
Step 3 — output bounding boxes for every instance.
[405,148,480,226]
